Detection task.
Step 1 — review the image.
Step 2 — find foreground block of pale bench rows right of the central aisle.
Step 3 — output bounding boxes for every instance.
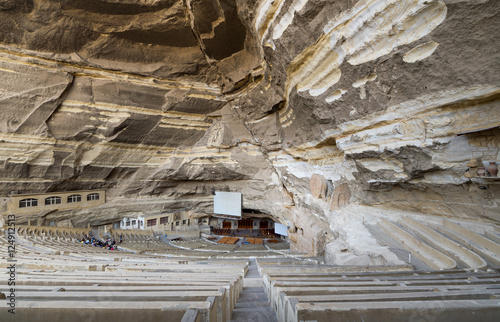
[258,259,500,322]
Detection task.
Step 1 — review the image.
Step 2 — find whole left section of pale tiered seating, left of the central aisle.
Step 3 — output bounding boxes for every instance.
[0,227,248,321]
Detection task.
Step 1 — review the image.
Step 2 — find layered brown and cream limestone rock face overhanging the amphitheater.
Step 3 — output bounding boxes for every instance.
[0,0,500,256]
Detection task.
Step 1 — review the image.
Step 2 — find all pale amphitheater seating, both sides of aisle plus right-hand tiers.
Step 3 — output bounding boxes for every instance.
[0,219,500,322]
